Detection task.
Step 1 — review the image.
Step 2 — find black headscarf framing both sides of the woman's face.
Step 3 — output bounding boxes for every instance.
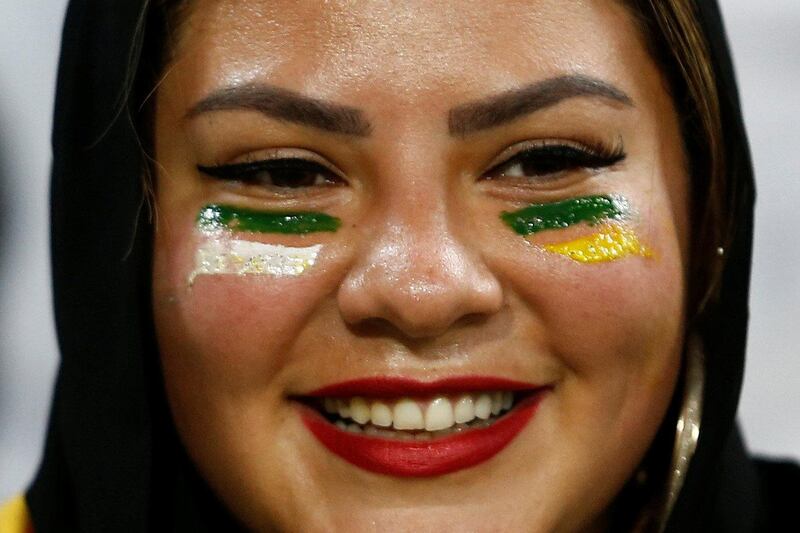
[26,0,800,533]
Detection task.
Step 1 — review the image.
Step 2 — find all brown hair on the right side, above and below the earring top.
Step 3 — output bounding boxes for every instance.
[614,4,728,531]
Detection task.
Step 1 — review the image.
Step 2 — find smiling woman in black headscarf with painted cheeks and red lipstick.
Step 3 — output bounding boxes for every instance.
[0,0,798,531]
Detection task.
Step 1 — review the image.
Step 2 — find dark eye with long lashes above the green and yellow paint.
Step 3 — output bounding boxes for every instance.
[483,141,626,181]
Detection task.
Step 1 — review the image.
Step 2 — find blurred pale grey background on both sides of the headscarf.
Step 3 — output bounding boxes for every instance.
[0,0,800,501]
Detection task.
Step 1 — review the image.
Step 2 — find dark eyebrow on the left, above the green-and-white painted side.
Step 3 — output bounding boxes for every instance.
[186,83,372,137]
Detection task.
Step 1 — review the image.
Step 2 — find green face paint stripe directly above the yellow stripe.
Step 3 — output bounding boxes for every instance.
[500,195,630,235]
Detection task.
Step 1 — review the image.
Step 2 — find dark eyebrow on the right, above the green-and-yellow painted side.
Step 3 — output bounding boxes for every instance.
[447,74,633,137]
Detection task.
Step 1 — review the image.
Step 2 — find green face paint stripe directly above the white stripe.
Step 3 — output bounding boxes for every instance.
[197,204,342,235]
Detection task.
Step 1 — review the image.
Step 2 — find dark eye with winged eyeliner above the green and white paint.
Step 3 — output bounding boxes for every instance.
[197,158,342,189]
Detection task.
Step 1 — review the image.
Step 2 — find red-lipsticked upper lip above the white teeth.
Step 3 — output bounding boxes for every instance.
[303,375,542,398]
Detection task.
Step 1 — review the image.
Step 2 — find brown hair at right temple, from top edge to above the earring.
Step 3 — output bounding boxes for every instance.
[625,0,736,321]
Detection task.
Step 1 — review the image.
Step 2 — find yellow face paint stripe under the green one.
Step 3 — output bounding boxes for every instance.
[544,223,653,263]
